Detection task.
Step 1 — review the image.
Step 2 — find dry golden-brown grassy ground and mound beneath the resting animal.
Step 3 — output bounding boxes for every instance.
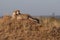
[0,16,60,40]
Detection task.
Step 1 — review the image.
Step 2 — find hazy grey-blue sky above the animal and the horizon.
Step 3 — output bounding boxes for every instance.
[0,0,60,15]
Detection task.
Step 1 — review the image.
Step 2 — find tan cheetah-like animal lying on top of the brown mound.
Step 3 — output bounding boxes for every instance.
[12,10,39,22]
